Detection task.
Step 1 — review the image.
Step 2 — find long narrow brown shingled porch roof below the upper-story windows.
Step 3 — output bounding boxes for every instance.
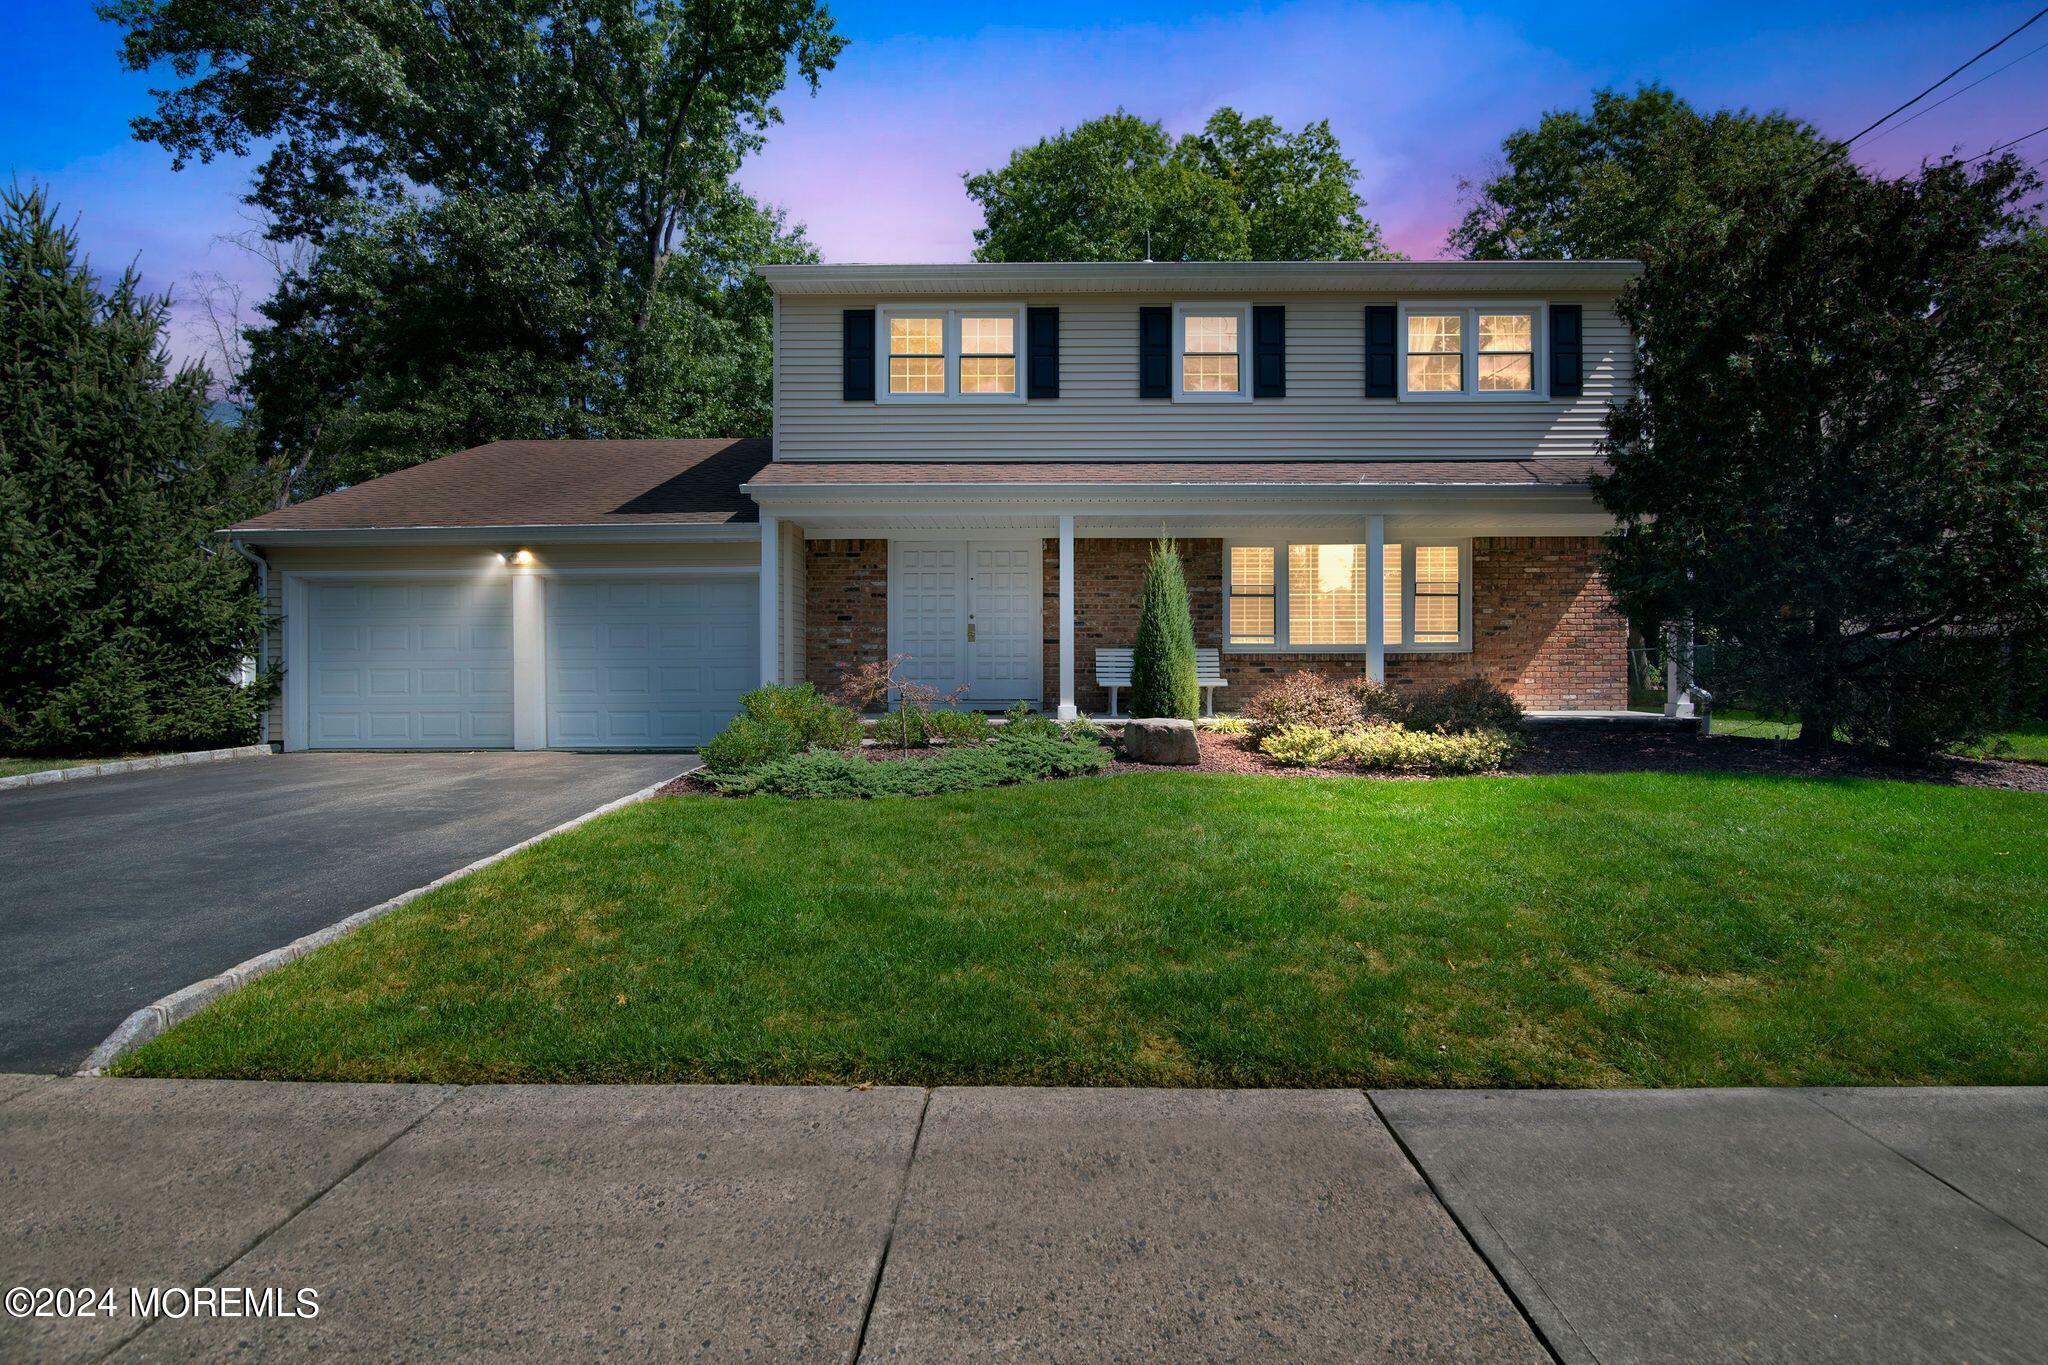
[754,456,1606,487]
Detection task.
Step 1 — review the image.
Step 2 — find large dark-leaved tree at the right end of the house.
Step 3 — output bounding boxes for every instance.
[1595,160,2048,753]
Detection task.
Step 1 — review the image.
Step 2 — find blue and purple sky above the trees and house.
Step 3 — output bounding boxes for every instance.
[0,0,2048,368]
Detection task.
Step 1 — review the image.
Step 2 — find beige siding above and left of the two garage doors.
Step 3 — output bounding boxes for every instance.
[258,540,762,745]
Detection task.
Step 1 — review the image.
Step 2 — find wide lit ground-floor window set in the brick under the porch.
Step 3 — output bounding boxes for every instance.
[1225,544,1470,653]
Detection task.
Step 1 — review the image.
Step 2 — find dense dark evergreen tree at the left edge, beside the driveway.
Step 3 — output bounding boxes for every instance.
[0,188,266,753]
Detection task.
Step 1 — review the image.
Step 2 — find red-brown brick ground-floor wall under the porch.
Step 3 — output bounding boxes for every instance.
[805,536,1628,712]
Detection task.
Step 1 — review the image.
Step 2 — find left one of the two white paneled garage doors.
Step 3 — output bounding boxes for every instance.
[305,579,512,749]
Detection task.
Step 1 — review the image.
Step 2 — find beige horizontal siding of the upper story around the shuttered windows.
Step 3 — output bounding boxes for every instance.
[774,293,1634,460]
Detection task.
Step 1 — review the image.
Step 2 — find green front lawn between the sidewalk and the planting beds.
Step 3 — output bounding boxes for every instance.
[125,774,2048,1087]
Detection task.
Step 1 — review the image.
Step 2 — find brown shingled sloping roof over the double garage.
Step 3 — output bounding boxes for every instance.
[233,436,768,532]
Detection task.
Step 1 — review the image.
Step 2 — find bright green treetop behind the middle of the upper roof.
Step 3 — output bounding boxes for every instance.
[967,108,1389,260]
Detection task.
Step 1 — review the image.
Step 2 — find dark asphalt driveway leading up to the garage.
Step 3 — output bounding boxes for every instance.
[0,753,696,1070]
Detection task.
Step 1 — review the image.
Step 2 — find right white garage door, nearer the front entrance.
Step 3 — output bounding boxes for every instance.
[547,577,760,749]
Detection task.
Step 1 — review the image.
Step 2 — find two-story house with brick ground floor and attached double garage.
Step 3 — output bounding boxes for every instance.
[231,262,1638,749]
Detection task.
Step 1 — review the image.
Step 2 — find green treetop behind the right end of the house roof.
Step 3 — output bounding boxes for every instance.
[1450,86,1829,260]
